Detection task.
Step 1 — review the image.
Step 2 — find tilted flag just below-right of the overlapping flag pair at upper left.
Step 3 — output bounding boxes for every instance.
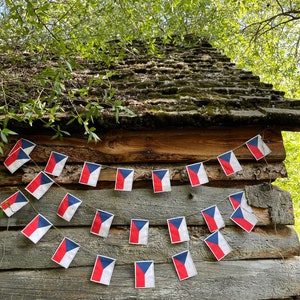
[25,171,54,199]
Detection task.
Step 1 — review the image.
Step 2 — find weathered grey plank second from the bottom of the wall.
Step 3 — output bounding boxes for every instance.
[0,226,300,270]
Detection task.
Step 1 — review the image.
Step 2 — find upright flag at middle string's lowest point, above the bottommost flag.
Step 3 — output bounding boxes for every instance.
[129,219,149,245]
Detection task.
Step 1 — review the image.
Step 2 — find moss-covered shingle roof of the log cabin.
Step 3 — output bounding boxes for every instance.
[1,40,300,130]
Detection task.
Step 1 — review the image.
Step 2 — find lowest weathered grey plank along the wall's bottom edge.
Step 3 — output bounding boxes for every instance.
[0,258,300,300]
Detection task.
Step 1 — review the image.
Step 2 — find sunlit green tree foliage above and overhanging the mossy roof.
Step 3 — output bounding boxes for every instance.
[0,0,300,232]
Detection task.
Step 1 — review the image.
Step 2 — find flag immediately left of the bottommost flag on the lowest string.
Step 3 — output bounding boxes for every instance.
[91,255,116,285]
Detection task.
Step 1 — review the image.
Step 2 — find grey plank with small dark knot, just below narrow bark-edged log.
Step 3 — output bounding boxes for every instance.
[0,185,294,227]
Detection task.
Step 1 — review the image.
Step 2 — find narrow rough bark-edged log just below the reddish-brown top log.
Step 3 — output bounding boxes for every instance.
[11,162,287,188]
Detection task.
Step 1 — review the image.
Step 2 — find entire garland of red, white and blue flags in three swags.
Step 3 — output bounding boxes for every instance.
[0,135,271,288]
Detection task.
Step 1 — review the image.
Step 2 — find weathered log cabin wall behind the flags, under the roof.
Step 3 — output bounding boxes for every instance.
[0,38,300,299]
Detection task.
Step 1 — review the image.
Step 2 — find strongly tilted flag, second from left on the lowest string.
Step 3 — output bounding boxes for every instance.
[21,214,52,244]
